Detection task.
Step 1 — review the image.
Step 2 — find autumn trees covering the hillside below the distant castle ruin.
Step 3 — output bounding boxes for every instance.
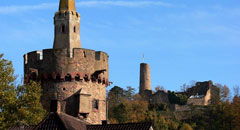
[108,85,240,130]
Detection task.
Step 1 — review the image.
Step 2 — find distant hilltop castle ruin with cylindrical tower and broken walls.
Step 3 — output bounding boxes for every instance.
[139,63,219,111]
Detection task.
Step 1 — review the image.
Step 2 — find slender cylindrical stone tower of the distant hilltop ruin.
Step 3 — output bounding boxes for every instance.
[139,63,151,95]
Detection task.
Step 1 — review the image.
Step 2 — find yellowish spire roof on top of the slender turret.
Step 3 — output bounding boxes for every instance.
[59,0,76,11]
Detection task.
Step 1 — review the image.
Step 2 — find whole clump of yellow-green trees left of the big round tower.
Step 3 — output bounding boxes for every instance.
[0,54,45,129]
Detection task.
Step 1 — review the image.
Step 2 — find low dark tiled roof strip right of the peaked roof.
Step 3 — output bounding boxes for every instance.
[87,122,152,130]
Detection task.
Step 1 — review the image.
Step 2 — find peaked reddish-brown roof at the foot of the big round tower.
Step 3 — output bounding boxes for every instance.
[35,112,89,130]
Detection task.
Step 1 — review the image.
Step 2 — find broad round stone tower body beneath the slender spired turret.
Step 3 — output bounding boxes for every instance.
[24,48,109,124]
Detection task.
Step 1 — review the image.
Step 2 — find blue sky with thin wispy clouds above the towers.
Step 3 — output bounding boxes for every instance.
[0,0,240,91]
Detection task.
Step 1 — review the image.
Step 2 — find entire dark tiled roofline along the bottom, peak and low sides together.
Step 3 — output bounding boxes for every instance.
[9,112,153,130]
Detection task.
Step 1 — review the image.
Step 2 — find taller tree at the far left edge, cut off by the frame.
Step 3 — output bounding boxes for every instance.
[0,54,17,129]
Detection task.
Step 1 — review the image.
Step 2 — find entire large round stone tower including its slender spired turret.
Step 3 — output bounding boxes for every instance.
[24,0,109,124]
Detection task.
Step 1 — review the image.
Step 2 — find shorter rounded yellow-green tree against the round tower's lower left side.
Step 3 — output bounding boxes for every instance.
[16,81,46,125]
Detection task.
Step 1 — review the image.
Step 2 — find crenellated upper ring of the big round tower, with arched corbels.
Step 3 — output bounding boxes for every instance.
[24,48,109,86]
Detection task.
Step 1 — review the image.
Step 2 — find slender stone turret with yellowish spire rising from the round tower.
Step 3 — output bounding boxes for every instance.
[53,0,81,53]
